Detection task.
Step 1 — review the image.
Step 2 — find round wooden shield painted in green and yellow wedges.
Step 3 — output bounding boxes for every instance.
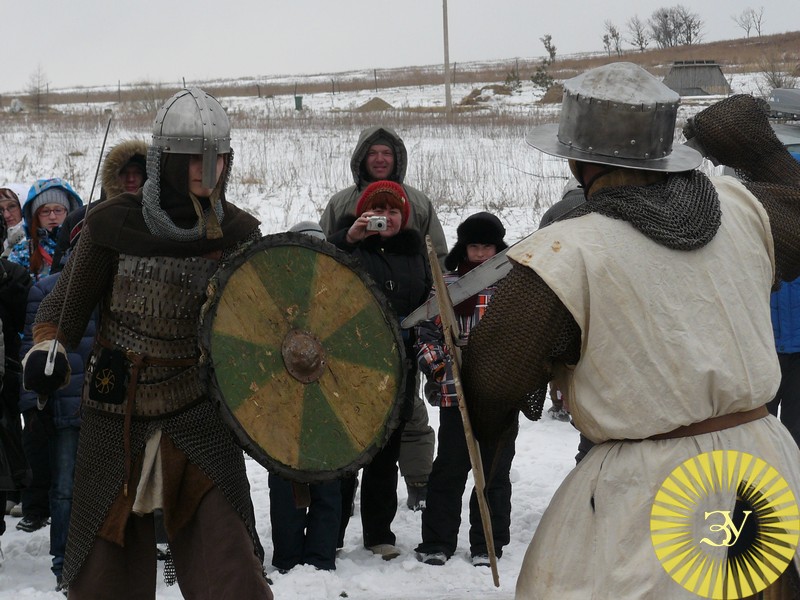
[200,233,406,483]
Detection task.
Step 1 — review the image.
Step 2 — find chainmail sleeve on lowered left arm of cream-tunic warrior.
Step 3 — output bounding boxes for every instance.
[462,264,580,443]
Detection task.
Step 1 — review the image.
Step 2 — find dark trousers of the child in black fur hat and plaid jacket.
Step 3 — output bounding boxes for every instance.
[416,407,515,558]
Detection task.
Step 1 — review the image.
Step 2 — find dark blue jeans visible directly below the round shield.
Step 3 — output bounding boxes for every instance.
[269,473,342,571]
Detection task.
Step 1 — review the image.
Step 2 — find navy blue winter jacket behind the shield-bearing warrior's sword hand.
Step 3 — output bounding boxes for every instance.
[19,273,95,428]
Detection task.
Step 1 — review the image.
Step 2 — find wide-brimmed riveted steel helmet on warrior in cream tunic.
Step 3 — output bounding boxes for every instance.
[527,62,703,172]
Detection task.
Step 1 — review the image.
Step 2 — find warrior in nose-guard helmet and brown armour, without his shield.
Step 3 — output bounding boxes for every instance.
[24,88,272,598]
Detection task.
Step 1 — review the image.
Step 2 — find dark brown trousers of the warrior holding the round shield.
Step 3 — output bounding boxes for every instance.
[69,488,272,600]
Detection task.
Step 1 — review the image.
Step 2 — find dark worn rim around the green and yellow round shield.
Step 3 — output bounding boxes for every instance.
[198,232,408,483]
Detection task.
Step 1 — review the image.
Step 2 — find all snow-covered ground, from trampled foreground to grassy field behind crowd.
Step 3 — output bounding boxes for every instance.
[0,69,780,600]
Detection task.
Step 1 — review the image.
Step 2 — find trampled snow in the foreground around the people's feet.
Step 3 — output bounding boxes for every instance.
[0,394,578,600]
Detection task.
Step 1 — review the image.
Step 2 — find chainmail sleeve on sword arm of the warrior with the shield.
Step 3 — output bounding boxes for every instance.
[34,224,117,348]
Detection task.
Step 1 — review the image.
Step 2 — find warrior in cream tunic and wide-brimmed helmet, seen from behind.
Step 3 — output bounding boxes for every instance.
[463,63,800,599]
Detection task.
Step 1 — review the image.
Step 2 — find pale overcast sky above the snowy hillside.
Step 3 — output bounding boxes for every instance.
[0,0,800,93]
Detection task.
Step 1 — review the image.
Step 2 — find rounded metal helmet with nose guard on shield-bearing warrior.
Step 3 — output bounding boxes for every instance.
[153,87,231,188]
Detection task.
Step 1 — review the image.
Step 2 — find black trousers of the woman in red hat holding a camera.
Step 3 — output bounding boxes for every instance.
[337,422,404,548]
